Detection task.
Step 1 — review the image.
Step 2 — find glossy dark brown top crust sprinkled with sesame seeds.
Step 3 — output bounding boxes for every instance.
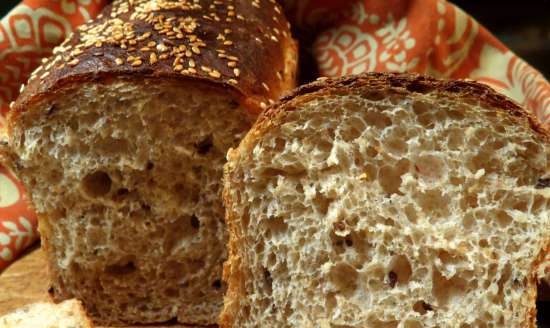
[12,0,296,117]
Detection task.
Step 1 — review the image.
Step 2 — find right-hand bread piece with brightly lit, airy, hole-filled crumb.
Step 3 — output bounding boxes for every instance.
[220,74,550,328]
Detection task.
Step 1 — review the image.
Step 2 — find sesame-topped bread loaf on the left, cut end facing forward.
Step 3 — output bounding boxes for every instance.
[3,0,296,324]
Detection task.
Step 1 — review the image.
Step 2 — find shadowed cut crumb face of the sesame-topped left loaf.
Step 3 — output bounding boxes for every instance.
[8,78,250,323]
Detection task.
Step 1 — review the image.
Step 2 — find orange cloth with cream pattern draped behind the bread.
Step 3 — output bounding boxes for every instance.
[0,0,550,270]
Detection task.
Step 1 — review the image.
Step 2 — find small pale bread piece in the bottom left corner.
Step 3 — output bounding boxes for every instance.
[0,299,93,328]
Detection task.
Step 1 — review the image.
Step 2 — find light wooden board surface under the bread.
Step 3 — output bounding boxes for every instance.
[0,246,550,328]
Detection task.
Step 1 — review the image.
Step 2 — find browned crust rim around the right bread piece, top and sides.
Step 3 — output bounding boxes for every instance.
[220,73,550,328]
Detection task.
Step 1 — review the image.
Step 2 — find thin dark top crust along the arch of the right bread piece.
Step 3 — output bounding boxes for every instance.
[253,72,550,141]
